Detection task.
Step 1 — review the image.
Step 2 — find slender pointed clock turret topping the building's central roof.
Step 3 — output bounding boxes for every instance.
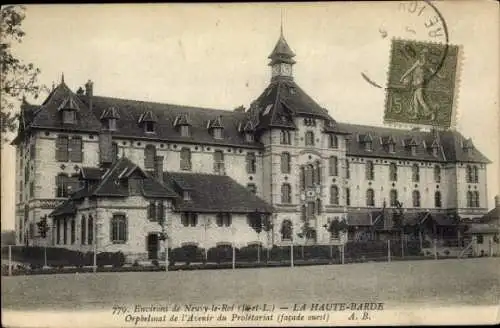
[268,27,295,81]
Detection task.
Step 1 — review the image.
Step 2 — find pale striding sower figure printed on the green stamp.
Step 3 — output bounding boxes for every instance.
[400,48,441,120]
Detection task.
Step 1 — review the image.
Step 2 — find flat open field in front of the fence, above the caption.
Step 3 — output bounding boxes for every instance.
[2,258,500,310]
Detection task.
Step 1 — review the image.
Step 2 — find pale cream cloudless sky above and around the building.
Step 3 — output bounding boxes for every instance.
[1,1,500,229]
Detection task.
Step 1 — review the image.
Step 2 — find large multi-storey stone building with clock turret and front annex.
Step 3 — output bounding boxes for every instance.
[13,30,489,257]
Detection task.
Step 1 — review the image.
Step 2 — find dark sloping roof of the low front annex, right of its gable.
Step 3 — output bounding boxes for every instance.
[164,172,273,213]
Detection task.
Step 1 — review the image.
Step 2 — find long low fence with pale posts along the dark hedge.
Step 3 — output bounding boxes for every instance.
[2,239,500,275]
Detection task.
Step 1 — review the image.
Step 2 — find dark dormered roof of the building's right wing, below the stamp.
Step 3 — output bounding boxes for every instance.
[337,123,490,163]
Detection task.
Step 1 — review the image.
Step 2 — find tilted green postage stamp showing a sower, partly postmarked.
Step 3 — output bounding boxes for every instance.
[384,39,459,128]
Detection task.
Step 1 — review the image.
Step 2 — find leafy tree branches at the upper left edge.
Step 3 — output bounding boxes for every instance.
[0,5,47,142]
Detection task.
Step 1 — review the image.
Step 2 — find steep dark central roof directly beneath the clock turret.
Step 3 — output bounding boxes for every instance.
[249,79,341,133]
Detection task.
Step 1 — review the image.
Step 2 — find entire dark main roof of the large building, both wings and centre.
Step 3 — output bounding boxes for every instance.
[12,79,491,163]
